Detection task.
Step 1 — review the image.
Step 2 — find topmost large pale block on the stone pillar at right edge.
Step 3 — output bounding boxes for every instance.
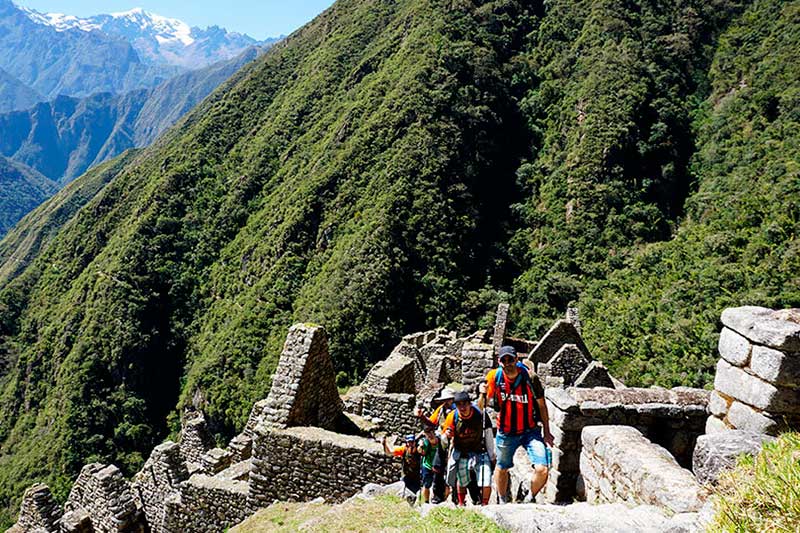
[722,306,800,352]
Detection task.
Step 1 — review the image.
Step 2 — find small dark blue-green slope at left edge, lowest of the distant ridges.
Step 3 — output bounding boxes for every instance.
[0,156,57,235]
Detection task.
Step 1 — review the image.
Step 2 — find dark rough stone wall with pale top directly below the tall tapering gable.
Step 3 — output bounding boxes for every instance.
[250,426,401,508]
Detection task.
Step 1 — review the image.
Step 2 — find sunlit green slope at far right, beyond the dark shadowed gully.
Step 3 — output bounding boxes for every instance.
[581,1,800,385]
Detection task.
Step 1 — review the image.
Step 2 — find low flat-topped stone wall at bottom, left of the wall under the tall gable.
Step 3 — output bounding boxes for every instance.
[163,474,253,533]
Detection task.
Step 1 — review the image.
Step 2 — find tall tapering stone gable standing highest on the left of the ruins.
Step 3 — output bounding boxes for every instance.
[264,324,344,429]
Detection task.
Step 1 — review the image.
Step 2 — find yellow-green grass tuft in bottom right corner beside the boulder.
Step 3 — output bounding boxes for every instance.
[709,433,800,532]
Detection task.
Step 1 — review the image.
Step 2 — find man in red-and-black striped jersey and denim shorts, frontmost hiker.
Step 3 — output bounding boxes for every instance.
[480,346,553,503]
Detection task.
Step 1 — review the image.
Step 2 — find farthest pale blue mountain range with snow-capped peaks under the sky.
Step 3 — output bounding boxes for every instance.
[0,0,277,108]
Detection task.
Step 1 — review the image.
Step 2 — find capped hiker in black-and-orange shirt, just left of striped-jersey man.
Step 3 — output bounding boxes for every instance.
[444,391,495,506]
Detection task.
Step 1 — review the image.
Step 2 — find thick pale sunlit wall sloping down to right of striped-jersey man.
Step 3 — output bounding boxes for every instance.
[580,426,707,513]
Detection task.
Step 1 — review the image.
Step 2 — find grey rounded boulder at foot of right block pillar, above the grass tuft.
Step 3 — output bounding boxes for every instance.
[692,430,775,484]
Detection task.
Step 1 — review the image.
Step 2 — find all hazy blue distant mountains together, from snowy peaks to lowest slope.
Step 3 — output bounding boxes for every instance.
[0,0,278,236]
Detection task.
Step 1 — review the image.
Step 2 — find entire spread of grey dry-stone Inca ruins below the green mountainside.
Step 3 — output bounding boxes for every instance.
[10,306,800,533]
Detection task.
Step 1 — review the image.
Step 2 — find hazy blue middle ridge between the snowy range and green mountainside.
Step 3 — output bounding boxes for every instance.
[0,48,260,187]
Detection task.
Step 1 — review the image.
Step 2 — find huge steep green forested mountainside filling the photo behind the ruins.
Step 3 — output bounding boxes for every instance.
[0,0,800,520]
